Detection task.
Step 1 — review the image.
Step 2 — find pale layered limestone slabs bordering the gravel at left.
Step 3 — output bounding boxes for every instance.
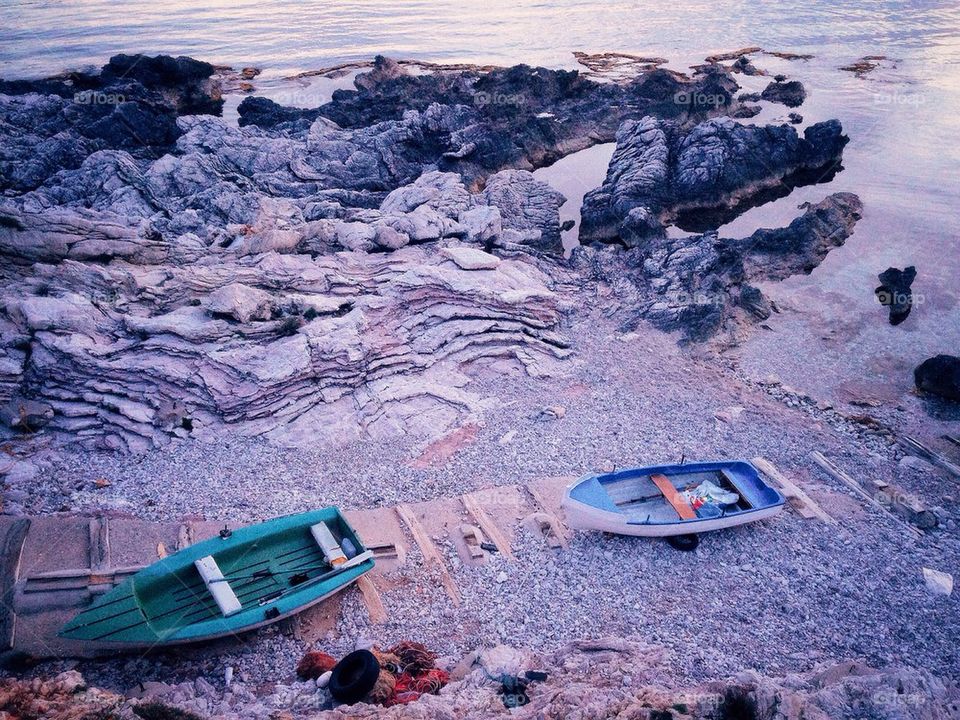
[0,242,567,450]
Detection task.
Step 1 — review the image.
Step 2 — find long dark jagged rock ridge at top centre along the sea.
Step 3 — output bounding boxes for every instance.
[238,57,737,189]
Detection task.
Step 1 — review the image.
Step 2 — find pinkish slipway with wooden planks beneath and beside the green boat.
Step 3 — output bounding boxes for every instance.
[0,480,568,658]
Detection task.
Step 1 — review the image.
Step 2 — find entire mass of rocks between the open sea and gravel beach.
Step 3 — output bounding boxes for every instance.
[0,56,860,452]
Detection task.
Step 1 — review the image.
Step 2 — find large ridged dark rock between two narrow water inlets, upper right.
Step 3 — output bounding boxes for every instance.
[580,116,847,244]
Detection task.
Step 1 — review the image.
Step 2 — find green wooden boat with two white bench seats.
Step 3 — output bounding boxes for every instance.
[60,507,373,646]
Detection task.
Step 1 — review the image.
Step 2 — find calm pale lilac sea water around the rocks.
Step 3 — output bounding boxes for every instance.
[0,0,960,404]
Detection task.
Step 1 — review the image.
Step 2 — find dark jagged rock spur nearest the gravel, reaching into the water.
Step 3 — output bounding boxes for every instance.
[572,193,862,341]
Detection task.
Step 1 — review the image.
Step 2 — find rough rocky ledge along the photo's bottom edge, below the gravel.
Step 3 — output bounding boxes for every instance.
[7,637,960,720]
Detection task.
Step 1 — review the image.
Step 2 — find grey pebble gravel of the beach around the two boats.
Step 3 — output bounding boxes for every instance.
[9,312,960,689]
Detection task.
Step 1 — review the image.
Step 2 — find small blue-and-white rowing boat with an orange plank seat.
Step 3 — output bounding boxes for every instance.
[562,460,785,537]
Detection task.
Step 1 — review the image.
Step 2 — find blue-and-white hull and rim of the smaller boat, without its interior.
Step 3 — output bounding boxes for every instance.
[561,461,785,537]
